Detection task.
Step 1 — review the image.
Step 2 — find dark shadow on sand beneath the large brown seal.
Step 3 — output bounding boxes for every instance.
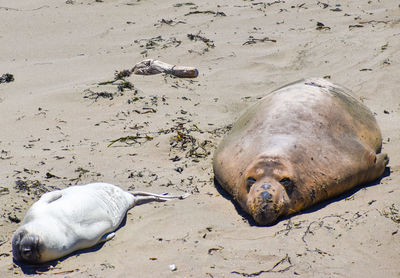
[214,167,390,227]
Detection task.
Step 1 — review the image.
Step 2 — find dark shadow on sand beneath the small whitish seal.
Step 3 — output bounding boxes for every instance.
[13,215,126,275]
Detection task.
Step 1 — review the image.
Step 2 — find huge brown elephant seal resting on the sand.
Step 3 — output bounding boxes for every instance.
[213,78,389,225]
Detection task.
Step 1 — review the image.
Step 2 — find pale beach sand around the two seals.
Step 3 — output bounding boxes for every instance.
[0,0,400,277]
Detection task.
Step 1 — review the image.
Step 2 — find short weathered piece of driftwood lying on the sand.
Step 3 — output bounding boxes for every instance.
[132,59,199,78]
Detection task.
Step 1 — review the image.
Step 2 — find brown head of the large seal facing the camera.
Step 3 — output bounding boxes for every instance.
[238,156,295,225]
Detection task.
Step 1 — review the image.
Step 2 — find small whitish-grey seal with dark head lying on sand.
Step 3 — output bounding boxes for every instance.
[12,183,187,263]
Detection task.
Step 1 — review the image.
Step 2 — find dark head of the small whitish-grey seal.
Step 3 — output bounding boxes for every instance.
[12,229,42,263]
